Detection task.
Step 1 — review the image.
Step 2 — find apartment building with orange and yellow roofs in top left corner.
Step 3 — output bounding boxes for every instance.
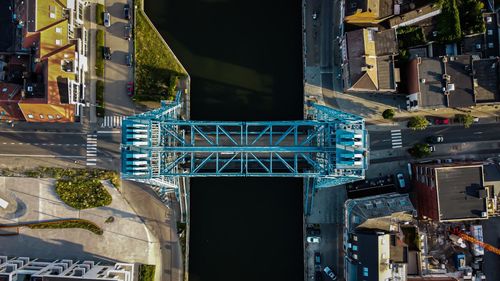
[0,0,88,122]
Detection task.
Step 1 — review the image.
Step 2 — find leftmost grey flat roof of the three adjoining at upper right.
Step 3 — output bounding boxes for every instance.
[418,58,447,108]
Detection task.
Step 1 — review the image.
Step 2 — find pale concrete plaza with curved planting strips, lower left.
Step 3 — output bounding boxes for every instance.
[0,177,156,264]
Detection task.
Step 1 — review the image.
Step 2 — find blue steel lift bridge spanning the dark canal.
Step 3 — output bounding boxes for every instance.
[121,93,368,210]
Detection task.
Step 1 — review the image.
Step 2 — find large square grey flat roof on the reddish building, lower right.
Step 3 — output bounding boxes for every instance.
[435,165,486,220]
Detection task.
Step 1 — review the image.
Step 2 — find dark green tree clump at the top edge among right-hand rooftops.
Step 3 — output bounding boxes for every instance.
[437,0,462,43]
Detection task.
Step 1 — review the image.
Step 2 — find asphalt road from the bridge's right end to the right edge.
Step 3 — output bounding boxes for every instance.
[369,124,500,151]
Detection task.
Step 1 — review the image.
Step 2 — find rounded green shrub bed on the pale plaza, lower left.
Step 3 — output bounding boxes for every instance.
[56,176,111,210]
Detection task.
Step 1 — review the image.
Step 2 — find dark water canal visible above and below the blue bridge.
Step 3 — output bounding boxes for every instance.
[145,0,303,281]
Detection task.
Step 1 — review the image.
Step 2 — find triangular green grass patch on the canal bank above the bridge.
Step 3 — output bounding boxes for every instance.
[134,10,187,101]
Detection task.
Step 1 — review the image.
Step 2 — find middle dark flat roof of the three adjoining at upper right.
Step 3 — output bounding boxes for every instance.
[446,55,475,107]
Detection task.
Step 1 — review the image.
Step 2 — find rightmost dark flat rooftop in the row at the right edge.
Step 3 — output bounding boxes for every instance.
[472,58,500,103]
